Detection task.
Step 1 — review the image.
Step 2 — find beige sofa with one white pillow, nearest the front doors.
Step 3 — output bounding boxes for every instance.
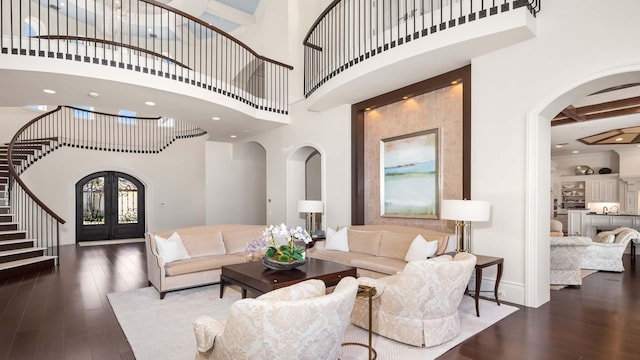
[145,224,265,299]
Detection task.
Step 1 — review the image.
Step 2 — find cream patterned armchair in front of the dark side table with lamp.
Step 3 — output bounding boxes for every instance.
[351,253,476,347]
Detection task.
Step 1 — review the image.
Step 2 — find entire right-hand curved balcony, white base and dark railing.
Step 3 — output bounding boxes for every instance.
[303,0,541,111]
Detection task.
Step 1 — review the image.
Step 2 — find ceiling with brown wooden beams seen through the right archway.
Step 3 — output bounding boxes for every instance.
[551,84,640,156]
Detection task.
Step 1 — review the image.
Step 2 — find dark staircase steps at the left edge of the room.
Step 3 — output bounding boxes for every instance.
[0,145,56,279]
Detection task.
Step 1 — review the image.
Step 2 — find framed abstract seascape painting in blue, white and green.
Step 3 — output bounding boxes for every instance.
[380,129,440,219]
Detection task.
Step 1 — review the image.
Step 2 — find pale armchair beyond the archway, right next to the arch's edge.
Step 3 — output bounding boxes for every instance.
[549,236,592,285]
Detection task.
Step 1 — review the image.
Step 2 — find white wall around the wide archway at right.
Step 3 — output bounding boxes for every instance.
[472,0,640,306]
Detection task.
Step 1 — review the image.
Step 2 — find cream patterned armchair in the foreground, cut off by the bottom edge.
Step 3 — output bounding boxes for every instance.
[193,277,358,360]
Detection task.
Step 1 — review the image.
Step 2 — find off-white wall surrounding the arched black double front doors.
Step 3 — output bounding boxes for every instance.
[22,136,205,245]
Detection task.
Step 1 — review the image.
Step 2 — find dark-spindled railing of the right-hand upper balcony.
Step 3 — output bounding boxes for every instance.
[303,0,541,97]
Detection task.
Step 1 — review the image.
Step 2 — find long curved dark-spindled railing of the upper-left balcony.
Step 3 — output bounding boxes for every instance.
[0,0,293,114]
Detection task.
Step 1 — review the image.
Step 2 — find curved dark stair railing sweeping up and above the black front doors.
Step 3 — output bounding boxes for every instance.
[7,106,206,257]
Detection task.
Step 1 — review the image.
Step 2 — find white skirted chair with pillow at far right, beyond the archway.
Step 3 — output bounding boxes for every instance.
[582,227,640,272]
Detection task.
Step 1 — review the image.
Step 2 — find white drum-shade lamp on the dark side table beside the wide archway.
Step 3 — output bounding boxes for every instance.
[440,200,491,252]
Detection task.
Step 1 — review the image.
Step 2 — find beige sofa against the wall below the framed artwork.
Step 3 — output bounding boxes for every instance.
[308,225,454,278]
